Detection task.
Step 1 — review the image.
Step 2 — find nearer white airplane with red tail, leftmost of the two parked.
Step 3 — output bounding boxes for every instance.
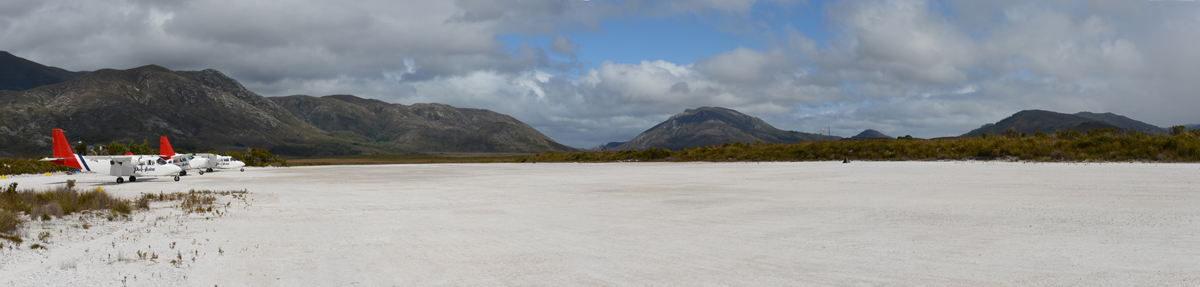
[42,128,182,184]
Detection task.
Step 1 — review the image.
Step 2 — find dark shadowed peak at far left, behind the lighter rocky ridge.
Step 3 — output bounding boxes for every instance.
[0,50,86,91]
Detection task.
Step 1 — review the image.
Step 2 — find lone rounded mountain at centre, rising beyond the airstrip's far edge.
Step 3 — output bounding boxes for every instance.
[613,107,841,150]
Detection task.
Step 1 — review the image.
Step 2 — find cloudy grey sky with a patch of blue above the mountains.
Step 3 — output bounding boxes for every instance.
[0,0,1200,148]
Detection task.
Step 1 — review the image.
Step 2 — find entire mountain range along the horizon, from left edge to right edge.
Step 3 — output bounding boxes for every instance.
[0,52,1200,156]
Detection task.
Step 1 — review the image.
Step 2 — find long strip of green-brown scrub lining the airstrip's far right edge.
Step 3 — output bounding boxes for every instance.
[530,126,1200,162]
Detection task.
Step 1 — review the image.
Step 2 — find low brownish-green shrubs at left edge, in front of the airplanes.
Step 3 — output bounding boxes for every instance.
[0,183,133,235]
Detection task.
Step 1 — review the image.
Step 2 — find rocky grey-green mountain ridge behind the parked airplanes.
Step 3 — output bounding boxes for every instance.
[0,53,577,156]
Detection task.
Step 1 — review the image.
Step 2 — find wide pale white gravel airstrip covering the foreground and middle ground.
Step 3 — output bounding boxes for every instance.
[0,162,1200,286]
